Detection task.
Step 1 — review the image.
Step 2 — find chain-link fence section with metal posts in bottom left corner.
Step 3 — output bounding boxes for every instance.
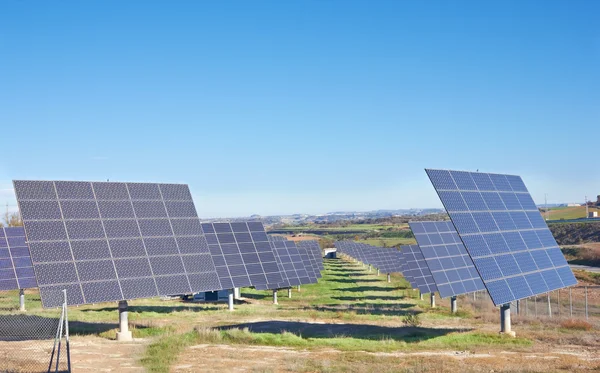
[0,290,70,373]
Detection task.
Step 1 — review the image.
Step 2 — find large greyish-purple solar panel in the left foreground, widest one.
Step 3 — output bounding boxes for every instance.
[14,180,222,307]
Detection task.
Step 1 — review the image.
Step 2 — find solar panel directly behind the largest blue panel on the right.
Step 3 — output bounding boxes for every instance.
[408,221,485,298]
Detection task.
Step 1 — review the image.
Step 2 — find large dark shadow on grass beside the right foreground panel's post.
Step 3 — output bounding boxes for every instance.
[218,321,468,343]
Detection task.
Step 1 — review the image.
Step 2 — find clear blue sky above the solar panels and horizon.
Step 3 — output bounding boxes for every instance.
[0,0,600,217]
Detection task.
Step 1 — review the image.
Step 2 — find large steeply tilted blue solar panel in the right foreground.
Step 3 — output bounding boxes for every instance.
[426,169,577,305]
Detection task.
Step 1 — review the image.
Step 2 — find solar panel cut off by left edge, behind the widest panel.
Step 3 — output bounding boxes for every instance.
[0,227,37,290]
